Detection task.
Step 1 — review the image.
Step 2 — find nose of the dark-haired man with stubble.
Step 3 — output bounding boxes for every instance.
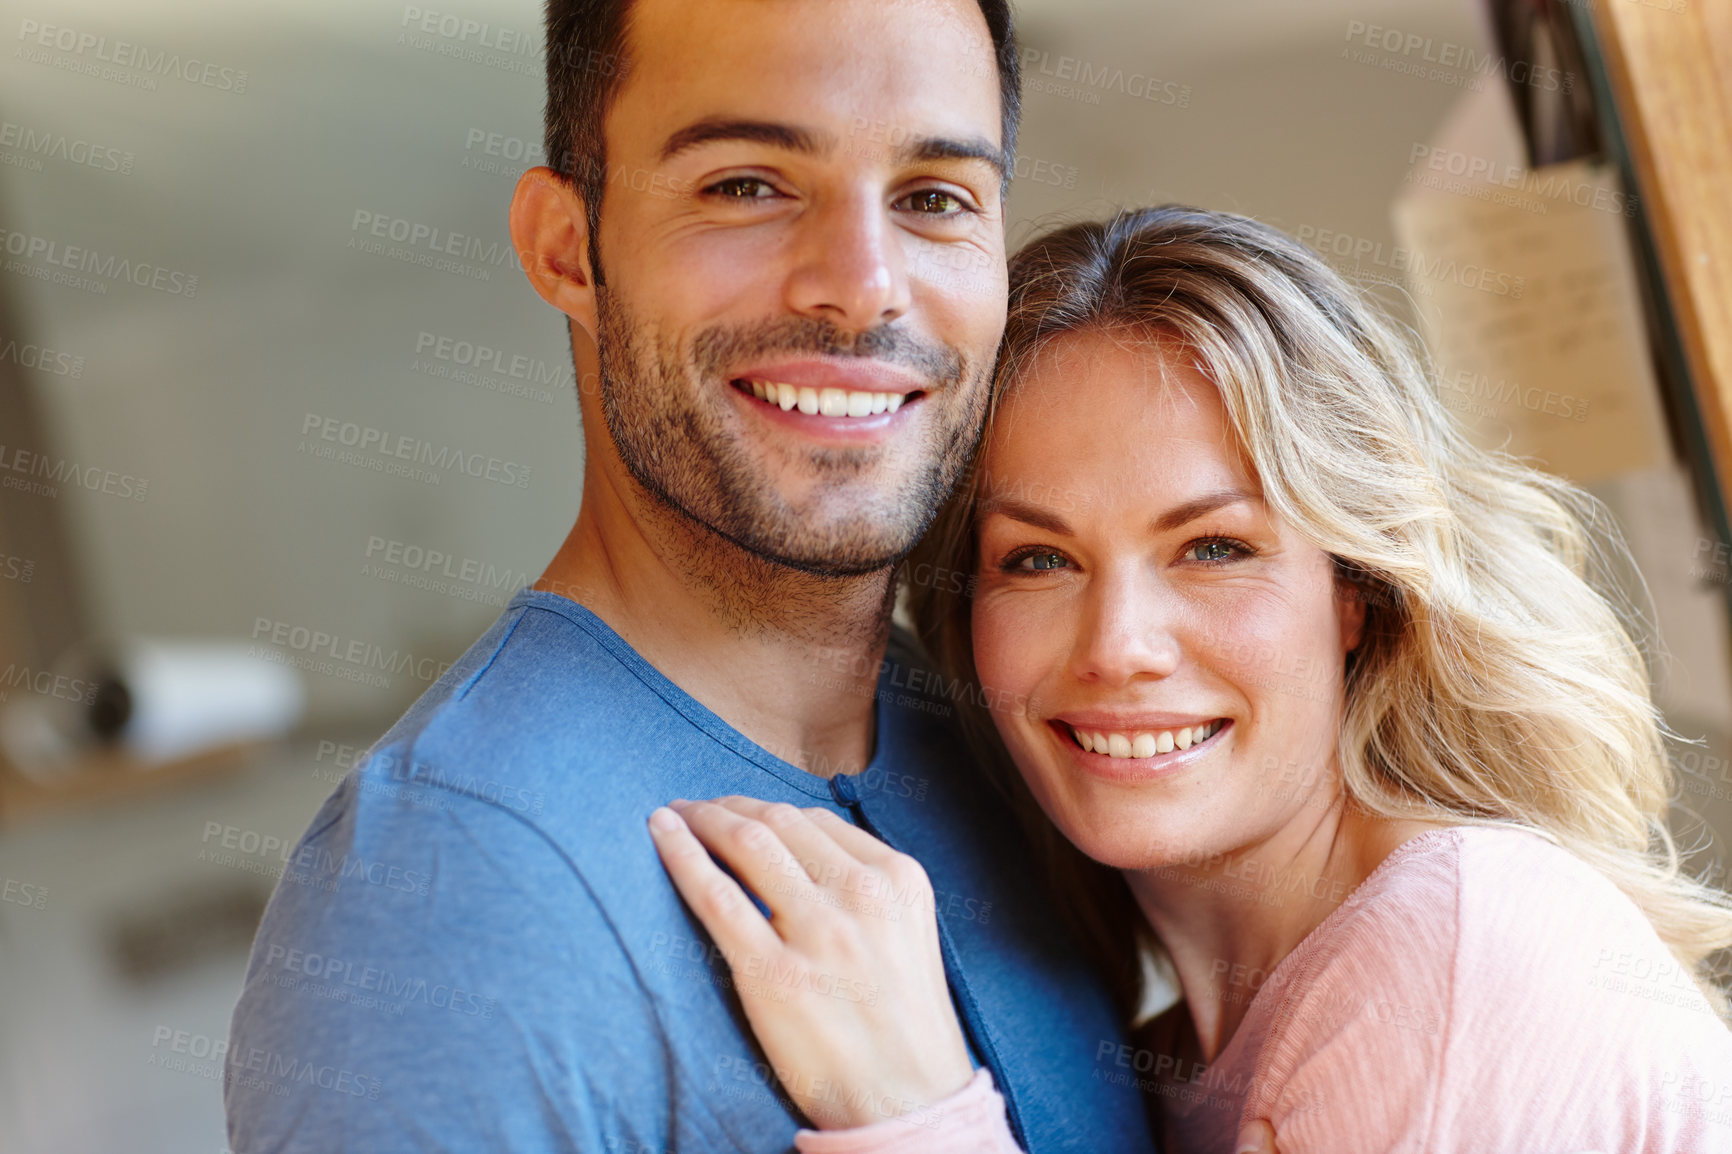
[786,192,909,333]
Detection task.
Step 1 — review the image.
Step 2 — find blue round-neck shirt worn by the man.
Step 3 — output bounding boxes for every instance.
[225,591,1152,1154]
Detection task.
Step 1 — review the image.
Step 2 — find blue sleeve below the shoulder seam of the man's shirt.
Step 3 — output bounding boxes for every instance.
[225,758,660,1151]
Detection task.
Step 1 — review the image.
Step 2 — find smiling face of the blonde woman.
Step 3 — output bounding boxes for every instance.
[973,333,1363,868]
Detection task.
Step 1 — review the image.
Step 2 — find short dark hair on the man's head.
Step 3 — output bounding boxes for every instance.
[546,0,1022,282]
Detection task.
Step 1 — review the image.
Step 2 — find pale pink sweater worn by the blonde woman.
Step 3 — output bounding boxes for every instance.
[795,827,1732,1154]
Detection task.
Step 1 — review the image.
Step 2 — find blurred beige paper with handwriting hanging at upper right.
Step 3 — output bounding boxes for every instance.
[1394,87,1670,482]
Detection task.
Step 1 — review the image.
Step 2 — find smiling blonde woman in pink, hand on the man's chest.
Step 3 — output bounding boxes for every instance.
[651,208,1732,1154]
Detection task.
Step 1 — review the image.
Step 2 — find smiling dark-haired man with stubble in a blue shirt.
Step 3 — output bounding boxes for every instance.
[227,0,1150,1154]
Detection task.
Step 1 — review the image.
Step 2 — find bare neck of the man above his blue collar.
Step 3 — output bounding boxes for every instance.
[535,457,892,776]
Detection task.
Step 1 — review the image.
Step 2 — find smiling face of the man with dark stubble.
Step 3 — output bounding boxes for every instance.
[598,0,1006,574]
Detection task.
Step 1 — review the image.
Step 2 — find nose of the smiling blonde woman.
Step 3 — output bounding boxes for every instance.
[1072,570,1181,686]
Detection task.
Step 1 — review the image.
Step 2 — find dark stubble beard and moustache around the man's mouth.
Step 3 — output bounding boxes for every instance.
[596,286,991,584]
